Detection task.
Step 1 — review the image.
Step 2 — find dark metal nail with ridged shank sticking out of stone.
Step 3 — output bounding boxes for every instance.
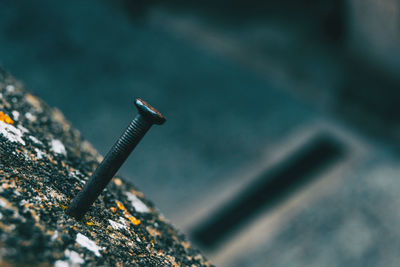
[66,98,166,220]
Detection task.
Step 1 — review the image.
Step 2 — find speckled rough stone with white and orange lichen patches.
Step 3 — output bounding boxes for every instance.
[0,69,211,267]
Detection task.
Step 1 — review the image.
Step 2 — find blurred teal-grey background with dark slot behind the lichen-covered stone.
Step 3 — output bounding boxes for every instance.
[0,0,400,266]
